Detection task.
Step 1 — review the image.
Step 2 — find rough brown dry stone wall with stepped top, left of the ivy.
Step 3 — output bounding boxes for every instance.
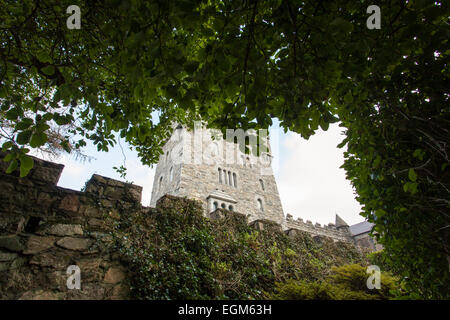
[0,155,142,299]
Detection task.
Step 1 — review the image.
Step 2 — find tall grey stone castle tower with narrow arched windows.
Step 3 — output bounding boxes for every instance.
[150,123,284,225]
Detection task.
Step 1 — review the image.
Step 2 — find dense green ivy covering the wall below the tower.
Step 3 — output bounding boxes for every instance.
[113,197,363,299]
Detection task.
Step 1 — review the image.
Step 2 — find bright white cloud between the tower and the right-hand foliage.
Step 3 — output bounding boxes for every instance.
[277,124,364,224]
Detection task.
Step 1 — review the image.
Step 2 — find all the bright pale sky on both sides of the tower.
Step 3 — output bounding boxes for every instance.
[34,121,364,225]
